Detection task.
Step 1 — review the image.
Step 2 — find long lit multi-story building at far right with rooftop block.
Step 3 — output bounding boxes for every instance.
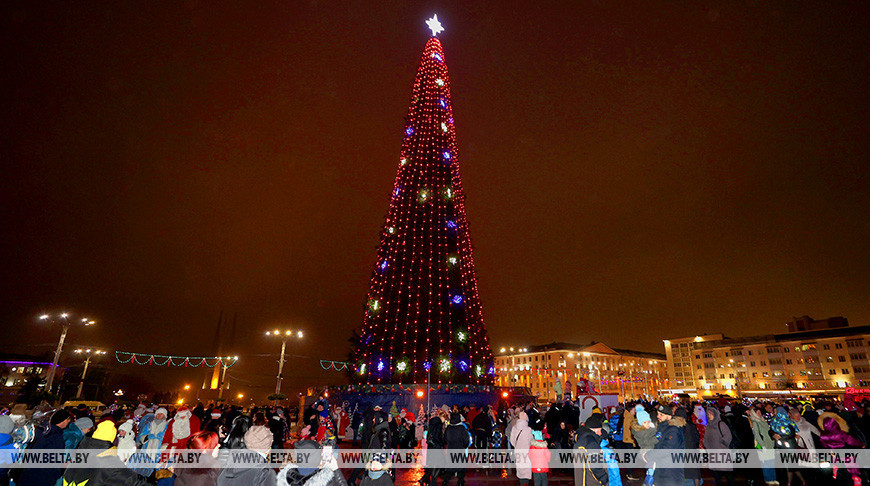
[665,316,870,397]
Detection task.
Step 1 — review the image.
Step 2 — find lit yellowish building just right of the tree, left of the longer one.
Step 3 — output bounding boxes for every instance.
[495,342,668,400]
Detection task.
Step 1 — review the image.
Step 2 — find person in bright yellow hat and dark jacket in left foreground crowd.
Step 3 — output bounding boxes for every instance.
[62,419,151,486]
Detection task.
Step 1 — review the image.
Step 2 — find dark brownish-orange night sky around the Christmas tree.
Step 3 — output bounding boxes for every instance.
[0,0,870,396]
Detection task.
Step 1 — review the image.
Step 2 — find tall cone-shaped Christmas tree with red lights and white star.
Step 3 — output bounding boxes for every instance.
[354,19,495,384]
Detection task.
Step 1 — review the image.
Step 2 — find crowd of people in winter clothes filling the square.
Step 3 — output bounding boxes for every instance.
[0,399,870,486]
